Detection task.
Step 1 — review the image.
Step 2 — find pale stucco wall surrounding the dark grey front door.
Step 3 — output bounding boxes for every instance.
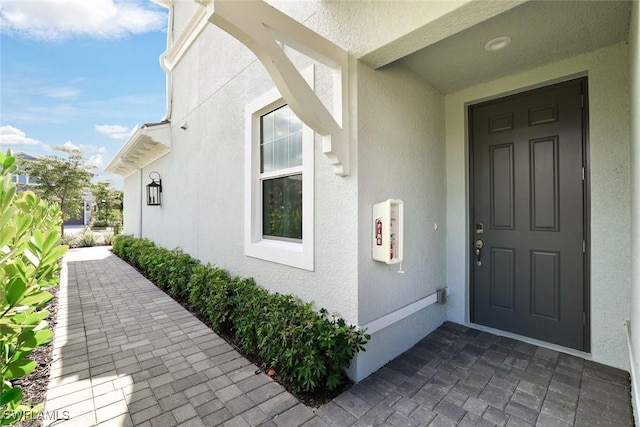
[445,44,631,370]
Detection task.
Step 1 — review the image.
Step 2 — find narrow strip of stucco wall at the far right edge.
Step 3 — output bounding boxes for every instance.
[629,1,640,423]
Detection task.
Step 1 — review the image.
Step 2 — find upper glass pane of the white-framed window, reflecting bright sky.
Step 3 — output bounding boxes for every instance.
[260,105,302,173]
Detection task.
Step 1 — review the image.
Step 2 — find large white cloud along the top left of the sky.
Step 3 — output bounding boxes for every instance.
[0,0,166,40]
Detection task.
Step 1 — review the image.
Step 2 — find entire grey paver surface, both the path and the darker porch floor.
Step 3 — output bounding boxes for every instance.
[43,248,633,427]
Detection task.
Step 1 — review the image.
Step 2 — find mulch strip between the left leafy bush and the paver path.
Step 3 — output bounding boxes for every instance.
[13,286,59,427]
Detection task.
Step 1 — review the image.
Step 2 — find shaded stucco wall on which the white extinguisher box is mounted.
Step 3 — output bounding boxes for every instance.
[357,63,446,378]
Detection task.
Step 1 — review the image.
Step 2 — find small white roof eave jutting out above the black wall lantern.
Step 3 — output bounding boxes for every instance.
[104,121,171,176]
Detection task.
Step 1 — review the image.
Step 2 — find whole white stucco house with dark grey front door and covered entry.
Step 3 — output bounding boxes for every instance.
[106,0,640,418]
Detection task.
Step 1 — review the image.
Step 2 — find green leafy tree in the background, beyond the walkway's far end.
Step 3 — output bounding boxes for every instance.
[23,147,94,234]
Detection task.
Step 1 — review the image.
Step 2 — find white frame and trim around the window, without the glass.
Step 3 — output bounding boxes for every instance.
[244,69,314,271]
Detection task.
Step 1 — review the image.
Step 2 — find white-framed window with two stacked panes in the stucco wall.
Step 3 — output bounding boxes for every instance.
[245,80,314,270]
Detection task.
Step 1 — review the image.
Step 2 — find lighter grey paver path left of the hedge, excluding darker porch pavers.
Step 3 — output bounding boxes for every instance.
[43,248,317,427]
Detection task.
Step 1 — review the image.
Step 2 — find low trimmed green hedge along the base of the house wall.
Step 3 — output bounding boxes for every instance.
[113,235,370,393]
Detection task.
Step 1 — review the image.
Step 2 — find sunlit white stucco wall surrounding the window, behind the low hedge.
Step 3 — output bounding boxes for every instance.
[138,10,357,323]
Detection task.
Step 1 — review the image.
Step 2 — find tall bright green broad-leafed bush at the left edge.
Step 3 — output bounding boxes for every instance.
[0,151,67,425]
